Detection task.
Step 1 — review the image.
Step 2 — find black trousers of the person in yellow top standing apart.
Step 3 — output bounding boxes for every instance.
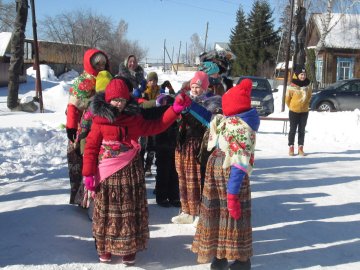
[288,111,309,146]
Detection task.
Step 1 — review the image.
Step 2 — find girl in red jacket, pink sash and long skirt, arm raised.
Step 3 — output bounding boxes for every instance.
[82,78,191,265]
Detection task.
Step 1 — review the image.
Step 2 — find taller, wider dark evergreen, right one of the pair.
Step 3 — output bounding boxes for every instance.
[247,0,279,77]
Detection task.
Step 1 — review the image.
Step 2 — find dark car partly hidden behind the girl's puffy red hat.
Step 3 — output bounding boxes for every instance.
[236,76,277,116]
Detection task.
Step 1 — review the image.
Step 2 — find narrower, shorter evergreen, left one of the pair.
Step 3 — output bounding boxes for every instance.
[229,5,249,76]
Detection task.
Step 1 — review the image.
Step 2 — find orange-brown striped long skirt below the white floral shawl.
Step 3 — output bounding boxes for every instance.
[191,150,253,263]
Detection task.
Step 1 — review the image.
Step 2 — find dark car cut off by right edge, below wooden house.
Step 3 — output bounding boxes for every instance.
[310,79,360,111]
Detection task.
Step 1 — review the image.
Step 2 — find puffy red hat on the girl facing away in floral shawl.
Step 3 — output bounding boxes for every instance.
[222,79,252,116]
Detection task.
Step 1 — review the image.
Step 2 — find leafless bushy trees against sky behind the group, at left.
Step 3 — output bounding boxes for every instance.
[41,11,147,73]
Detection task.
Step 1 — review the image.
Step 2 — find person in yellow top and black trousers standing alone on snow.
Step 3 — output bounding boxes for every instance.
[285,66,312,156]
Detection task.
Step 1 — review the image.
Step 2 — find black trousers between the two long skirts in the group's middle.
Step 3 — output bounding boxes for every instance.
[155,147,180,202]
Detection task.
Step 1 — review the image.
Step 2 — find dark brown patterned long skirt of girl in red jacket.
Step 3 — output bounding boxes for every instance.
[93,155,149,256]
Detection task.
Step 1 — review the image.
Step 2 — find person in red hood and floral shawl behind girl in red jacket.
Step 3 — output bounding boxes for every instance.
[66,49,109,205]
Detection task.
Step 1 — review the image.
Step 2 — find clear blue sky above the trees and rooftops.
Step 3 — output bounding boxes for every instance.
[22,0,281,62]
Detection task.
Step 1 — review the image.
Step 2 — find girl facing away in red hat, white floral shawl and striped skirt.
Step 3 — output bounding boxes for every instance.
[192,79,260,270]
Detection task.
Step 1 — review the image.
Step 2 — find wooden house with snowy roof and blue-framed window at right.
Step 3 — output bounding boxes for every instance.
[306,13,360,86]
